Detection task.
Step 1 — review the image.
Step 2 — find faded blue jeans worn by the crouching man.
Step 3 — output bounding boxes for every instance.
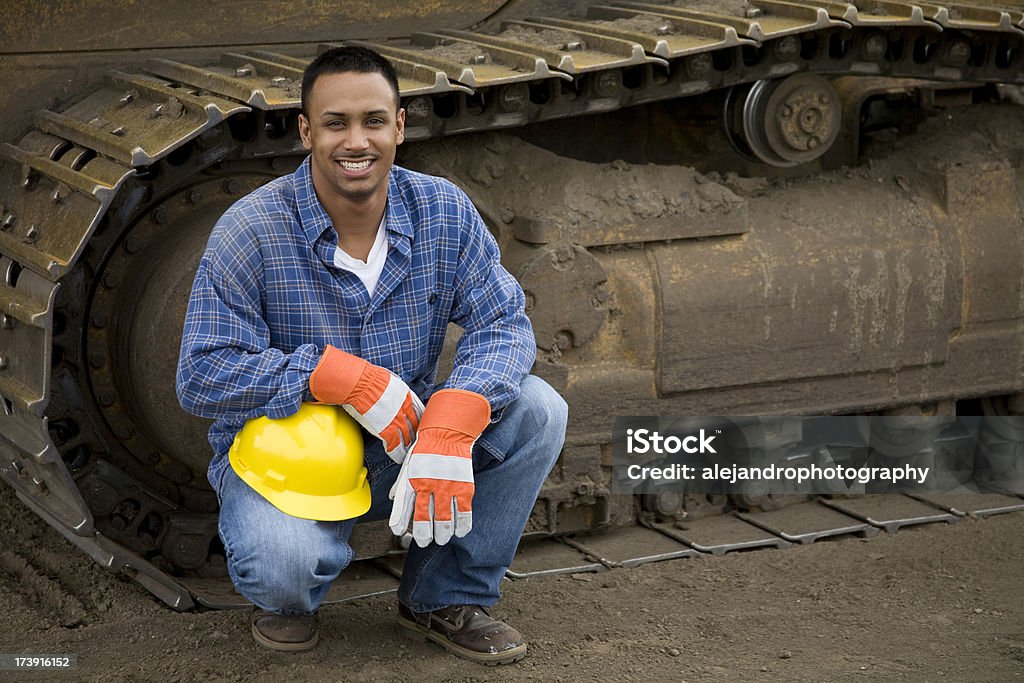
[217,376,568,614]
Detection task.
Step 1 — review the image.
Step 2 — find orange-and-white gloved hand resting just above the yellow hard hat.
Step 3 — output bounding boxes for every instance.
[309,345,423,464]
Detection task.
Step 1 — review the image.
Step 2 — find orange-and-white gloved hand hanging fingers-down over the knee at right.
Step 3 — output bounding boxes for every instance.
[389,389,490,548]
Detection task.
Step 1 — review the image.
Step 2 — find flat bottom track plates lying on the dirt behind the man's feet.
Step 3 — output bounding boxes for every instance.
[182,494,1024,609]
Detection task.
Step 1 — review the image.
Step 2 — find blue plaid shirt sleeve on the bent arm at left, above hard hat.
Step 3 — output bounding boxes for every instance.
[176,212,319,421]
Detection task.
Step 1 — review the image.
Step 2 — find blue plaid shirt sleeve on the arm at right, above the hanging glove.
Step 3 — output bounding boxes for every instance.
[444,190,537,421]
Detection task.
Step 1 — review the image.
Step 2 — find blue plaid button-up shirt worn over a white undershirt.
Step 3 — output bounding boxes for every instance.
[177,158,537,486]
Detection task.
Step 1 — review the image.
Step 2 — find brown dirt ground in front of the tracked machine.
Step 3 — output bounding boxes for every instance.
[0,485,1024,681]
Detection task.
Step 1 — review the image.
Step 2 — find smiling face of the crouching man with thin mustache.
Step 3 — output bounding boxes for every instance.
[299,72,406,208]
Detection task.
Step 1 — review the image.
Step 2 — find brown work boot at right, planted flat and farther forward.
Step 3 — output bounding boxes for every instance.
[398,603,526,665]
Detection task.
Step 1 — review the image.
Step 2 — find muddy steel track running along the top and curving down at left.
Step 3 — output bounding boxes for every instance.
[0,0,1024,609]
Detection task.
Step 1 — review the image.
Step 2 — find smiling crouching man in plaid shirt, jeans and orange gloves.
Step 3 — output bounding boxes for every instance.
[177,47,566,664]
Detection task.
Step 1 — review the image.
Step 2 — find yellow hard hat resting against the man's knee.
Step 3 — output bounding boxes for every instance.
[227,403,370,521]
